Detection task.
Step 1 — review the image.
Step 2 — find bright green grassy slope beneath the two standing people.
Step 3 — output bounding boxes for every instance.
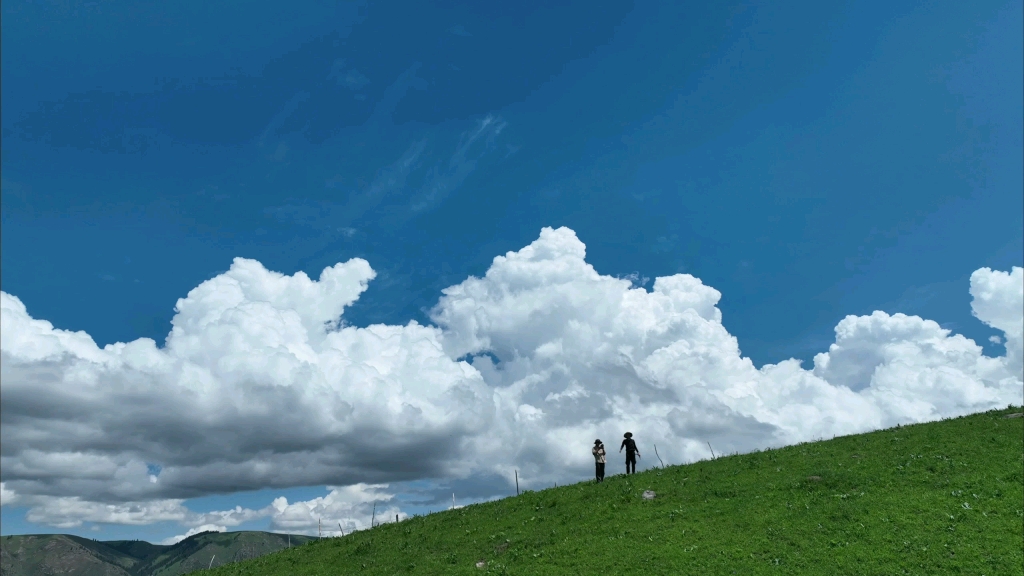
[201,408,1024,576]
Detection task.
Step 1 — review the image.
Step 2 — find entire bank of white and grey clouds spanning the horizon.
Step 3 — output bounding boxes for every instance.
[0,228,1024,537]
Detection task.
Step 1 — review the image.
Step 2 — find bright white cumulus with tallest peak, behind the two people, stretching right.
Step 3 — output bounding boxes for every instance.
[432,229,1024,482]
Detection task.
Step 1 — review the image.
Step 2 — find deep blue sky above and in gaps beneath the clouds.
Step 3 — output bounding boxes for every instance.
[0,0,1024,541]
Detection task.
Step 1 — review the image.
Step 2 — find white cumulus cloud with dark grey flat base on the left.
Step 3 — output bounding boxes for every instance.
[0,258,494,502]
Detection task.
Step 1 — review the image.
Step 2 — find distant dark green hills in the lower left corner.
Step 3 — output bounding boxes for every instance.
[0,532,314,576]
